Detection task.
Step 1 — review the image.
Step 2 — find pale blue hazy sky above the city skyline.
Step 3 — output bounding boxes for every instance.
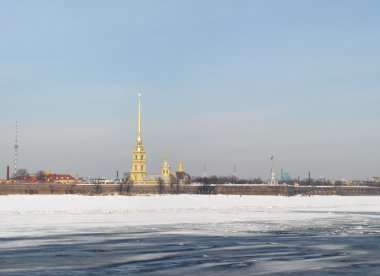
[0,0,380,179]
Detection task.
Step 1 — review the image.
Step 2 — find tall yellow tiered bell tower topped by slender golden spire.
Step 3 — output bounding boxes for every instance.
[130,93,146,183]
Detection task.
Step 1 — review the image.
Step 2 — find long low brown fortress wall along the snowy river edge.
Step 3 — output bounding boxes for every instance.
[0,184,380,196]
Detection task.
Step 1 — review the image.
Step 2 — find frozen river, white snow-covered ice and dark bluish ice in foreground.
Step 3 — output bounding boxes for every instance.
[0,195,380,275]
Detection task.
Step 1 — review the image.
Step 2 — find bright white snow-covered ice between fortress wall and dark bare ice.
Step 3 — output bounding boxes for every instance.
[0,195,380,237]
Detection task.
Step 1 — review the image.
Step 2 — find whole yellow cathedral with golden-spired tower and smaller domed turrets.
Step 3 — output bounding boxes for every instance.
[130,93,190,184]
